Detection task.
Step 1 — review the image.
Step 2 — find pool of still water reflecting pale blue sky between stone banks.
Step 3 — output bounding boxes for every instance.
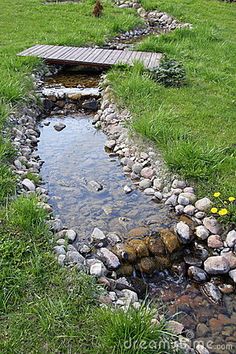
[39,116,174,237]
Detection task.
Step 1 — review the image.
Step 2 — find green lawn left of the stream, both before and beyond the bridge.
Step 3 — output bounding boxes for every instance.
[0,0,177,354]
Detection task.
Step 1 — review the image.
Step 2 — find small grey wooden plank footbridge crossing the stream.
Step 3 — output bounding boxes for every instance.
[18,44,162,69]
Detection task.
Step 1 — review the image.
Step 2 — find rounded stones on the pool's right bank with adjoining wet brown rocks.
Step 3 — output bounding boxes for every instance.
[89,76,236,301]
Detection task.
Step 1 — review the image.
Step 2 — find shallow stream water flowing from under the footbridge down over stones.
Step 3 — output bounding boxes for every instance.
[38,68,236,354]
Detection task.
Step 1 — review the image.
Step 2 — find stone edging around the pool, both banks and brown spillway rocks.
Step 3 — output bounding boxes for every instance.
[8,63,236,352]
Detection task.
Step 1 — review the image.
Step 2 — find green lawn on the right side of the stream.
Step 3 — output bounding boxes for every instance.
[107,0,236,195]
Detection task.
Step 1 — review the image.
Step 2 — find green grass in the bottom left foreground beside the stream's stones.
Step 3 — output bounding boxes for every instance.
[0,197,179,354]
